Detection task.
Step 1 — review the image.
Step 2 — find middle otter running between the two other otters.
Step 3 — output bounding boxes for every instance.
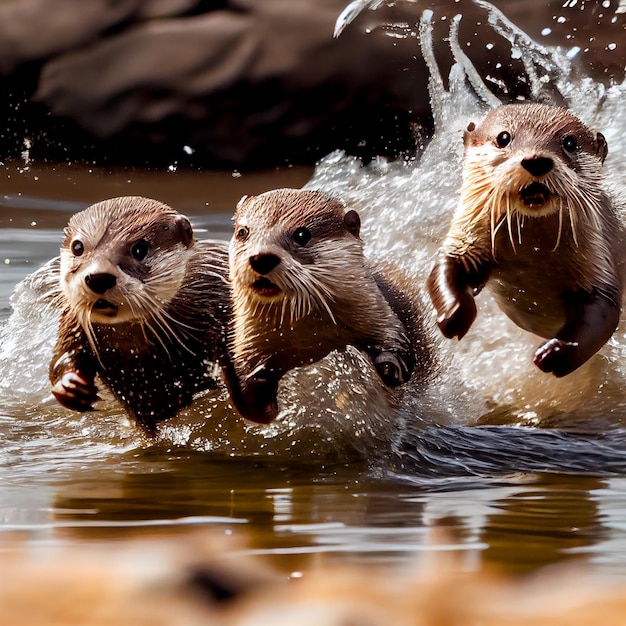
[229,189,431,422]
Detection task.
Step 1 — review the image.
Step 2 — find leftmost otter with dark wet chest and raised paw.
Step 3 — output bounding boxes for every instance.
[50,196,231,433]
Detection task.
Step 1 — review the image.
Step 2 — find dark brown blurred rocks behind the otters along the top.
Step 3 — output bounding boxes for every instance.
[0,0,626,169]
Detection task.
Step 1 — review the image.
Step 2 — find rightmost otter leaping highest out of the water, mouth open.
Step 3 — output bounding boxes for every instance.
[427,103,624,377]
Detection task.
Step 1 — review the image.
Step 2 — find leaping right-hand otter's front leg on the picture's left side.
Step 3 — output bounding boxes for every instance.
[426,255,489,339]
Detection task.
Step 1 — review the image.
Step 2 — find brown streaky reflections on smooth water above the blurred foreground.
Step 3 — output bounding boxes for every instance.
[11,449,626,573]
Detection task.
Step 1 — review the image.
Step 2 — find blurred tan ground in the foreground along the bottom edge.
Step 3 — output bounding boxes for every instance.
[0,533,626,626]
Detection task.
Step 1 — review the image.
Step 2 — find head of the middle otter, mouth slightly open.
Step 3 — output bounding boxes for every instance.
[230,189,363,319]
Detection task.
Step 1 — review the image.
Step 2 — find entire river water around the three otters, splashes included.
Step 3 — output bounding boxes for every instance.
[0,1,626,576]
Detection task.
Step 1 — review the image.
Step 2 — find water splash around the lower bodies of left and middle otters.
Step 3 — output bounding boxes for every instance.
[0,258,403,458]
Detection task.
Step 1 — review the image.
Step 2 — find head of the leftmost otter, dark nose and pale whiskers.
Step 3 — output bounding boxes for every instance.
[61,196,193,331]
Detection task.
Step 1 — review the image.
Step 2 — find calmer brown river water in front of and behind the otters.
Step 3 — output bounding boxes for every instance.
[0,157,626,576]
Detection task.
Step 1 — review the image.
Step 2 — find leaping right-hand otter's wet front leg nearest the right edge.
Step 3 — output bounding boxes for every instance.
[533,290,621,377]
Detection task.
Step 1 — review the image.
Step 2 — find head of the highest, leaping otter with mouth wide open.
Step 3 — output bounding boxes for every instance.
[464,104,607,220]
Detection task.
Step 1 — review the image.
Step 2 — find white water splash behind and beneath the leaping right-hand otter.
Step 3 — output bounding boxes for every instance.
[308,0,626,429]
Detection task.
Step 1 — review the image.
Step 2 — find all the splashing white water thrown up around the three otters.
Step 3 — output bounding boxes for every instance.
[0,0,626,470]
